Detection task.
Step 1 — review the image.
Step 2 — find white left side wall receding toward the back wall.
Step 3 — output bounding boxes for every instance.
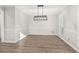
[15,8,29,39]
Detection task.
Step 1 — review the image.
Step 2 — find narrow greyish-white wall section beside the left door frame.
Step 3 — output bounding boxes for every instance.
[4,7,16,42]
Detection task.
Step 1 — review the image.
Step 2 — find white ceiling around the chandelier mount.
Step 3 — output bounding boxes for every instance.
[16,5,66,15]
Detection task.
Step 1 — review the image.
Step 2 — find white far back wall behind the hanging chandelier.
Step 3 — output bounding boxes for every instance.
[29,15,56,35]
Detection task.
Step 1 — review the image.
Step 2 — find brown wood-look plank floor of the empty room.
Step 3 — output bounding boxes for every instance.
[0,35,76,53]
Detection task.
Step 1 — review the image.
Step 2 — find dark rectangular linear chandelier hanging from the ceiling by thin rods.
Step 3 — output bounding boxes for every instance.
[33,5,47,21]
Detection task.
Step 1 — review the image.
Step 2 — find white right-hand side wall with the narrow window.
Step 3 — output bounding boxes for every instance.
[58,6,79,51]
